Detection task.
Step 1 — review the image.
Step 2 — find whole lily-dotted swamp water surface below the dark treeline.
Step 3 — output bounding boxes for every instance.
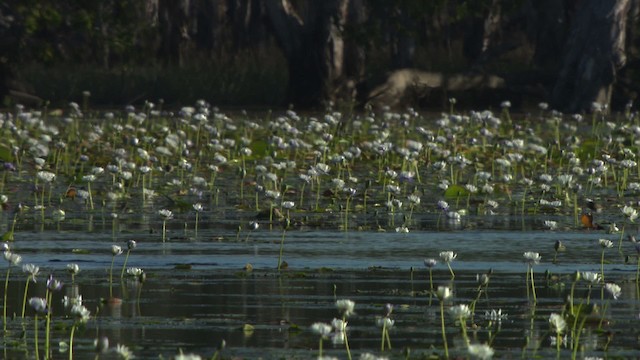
[0,105,640,359]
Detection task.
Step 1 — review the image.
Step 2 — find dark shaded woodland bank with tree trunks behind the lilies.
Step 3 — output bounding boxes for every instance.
[0,0,639,112]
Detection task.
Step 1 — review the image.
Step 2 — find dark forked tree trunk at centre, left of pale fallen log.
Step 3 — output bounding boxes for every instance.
[265,0,349,107]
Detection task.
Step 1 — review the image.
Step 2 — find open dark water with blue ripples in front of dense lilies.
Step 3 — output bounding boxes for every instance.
[3,224,640,358]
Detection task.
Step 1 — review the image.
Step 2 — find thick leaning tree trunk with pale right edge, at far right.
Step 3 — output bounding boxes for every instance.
[551,0,630,112]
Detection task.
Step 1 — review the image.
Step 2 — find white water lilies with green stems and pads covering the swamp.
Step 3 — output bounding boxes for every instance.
[0,98,640,359]
